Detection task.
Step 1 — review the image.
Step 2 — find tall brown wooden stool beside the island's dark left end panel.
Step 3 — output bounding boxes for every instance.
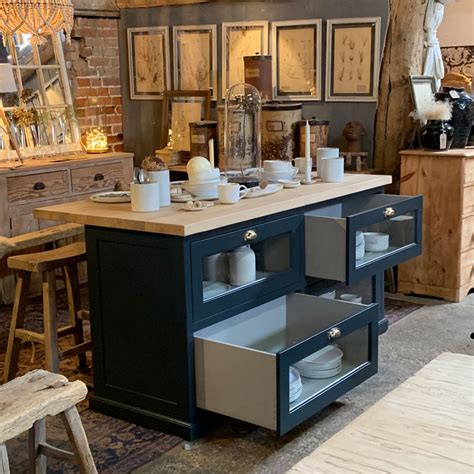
[4,242,91,382]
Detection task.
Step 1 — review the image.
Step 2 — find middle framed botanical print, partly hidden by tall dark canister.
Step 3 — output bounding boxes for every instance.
[221,21,268,98]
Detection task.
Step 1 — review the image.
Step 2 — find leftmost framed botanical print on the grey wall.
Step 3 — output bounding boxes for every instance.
[127,26,171,100]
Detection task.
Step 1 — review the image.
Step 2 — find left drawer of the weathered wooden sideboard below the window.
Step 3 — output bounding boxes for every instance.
[7,170,69,202]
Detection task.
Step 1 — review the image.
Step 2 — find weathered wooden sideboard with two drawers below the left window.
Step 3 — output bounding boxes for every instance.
[0,153,133,304]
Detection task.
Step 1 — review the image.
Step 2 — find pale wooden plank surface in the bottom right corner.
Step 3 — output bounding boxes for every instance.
[289,352,474,474]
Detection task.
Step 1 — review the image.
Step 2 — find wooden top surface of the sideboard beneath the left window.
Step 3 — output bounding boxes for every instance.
[0,151,133,174]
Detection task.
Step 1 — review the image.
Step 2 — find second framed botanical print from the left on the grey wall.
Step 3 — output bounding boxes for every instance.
[173,25,217,100]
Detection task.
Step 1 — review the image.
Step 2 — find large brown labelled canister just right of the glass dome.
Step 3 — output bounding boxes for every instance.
[262,102,303,161]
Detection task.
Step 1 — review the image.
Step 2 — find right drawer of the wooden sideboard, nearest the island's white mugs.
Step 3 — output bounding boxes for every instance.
[71,161,124,193]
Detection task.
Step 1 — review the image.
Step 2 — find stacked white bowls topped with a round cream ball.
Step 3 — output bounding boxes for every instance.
[183,156,225,199]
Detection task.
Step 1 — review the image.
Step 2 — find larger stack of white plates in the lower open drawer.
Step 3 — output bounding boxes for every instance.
[295,345,344,379]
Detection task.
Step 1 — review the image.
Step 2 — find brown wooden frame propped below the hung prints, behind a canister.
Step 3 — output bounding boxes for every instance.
[161,90,211,152]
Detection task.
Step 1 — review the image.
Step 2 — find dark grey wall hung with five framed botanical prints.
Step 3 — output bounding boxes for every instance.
[119,0,388,160]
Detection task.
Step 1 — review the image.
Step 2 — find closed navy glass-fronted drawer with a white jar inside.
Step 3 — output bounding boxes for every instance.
[191,215,303,321]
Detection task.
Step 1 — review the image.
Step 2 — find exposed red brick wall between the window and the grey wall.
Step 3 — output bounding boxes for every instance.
[64,17,123,151]
